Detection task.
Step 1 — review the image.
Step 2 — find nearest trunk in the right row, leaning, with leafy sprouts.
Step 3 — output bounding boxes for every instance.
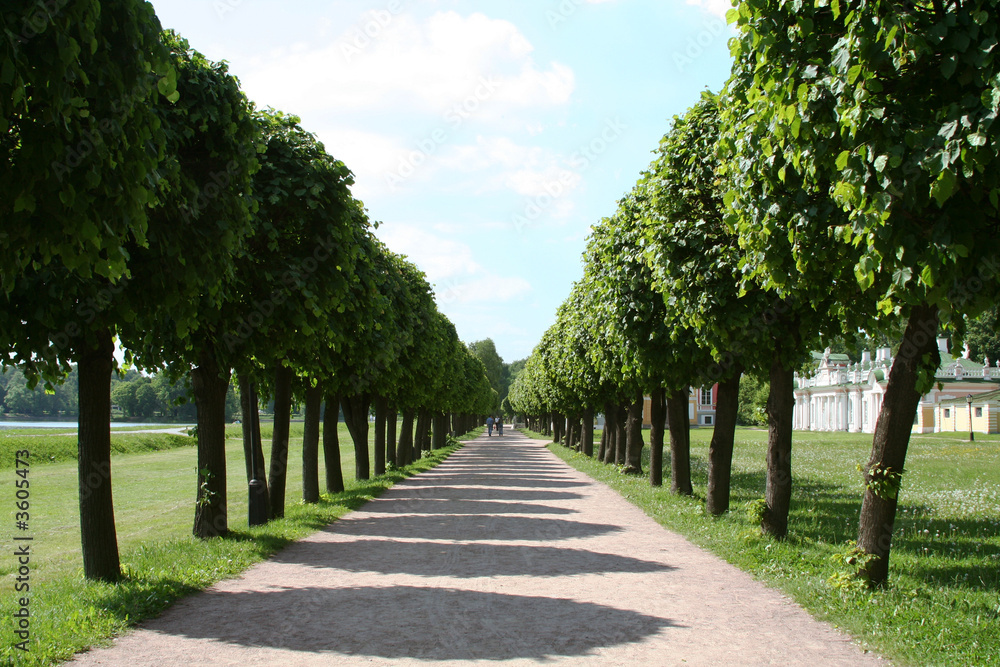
[858,305,941,587]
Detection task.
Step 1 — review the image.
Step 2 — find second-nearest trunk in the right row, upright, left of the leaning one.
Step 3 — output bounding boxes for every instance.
[761,350,796,539]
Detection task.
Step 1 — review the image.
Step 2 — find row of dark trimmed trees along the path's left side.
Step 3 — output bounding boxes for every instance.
[0,0,496,581]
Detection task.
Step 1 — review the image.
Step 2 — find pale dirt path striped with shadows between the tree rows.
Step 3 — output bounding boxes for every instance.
[68,431,884,667]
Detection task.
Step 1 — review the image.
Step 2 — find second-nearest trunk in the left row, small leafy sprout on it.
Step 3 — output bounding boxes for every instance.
[191,351,230,538]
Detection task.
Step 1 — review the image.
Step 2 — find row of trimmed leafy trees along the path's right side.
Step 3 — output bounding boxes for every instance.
[510,0,1000,585]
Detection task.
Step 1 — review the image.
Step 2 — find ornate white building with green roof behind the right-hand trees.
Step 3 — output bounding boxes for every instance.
[793,338,1000,433]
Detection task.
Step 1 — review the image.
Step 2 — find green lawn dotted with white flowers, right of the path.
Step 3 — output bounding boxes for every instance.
[550,429,1000,665]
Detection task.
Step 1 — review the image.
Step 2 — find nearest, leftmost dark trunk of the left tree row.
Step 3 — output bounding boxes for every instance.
[77,330,121,582]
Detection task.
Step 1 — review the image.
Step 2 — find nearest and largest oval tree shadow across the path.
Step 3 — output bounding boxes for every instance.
[149,586,681,660]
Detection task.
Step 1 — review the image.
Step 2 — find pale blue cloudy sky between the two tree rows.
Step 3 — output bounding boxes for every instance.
[152,0,733,362]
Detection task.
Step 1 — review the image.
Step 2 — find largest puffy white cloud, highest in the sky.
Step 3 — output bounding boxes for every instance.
[242,11,575,117]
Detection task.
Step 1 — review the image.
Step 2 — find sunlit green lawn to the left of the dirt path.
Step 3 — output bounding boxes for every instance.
[0,424,472,665]
